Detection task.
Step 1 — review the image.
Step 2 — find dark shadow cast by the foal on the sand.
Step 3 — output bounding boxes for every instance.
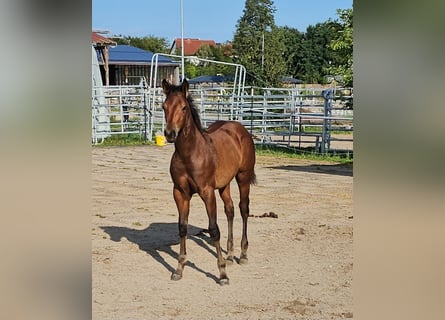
[100,222,219,282]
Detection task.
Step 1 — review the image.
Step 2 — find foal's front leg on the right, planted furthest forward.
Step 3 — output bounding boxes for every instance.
[199,187,229,285]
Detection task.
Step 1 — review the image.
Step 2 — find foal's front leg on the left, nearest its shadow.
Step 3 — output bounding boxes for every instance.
[171,187,190,280]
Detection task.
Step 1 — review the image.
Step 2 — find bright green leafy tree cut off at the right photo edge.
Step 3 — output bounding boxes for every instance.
[329,8,354,87]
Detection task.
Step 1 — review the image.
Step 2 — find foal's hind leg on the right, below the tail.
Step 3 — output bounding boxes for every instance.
[236,171,252,264]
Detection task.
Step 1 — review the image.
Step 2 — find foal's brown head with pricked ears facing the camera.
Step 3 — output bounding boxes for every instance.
[162,79,190,142]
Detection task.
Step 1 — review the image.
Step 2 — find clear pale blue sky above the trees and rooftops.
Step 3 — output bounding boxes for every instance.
[92,0,353,43]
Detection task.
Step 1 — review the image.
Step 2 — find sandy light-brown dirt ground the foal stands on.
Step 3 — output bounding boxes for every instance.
[91,144,353,320]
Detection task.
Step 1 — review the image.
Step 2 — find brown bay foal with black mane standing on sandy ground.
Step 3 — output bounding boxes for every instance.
[162,79,256,285]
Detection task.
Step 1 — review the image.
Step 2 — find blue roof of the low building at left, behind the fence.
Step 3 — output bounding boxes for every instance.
[108,44,179,65]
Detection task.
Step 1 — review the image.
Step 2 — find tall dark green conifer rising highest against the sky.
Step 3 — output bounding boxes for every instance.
[233,0,286,86]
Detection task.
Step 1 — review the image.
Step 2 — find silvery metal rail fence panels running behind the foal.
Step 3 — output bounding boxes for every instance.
[93,82,353,154]
